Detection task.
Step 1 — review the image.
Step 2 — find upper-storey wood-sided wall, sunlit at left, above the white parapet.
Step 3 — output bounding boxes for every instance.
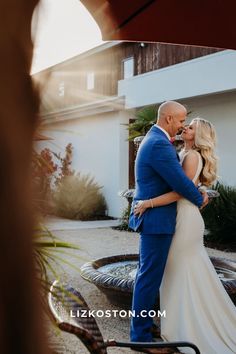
[35,42,219,110]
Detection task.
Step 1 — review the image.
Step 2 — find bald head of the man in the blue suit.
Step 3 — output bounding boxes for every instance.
[157,101,187,137]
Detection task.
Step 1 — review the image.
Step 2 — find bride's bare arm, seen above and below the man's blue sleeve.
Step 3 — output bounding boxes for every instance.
[134,151,199,216]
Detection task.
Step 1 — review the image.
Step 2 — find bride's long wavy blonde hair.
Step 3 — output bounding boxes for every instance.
[192,117,217,186]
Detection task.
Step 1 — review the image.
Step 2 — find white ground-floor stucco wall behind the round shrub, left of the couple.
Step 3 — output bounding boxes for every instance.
[38,111,129,217]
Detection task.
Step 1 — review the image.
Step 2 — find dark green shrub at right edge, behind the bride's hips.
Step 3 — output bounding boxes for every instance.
[202,182,236,244]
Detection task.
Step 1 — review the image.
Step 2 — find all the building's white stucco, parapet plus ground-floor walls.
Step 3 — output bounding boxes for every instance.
[39,50,236,217]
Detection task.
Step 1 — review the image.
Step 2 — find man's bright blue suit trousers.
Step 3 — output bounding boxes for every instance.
[130,233,173,342]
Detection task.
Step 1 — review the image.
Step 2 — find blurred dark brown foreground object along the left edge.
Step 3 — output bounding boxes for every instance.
[0,0,48,354]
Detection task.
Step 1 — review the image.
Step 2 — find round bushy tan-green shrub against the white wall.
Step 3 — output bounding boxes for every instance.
[53,174,107,220]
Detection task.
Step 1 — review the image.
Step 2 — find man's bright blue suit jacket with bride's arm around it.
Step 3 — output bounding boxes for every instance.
[129,126,203,234]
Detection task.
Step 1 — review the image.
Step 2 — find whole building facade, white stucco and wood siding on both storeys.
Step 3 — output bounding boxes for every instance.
[34,43,231,217]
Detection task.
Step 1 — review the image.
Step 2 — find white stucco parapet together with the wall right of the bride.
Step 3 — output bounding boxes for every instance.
[118,50,236,186]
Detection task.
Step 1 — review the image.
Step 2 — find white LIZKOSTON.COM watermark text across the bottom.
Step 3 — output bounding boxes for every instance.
[70,310,166,318]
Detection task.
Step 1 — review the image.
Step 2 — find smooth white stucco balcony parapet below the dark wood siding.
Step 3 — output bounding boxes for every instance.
[118,50,236,108]
